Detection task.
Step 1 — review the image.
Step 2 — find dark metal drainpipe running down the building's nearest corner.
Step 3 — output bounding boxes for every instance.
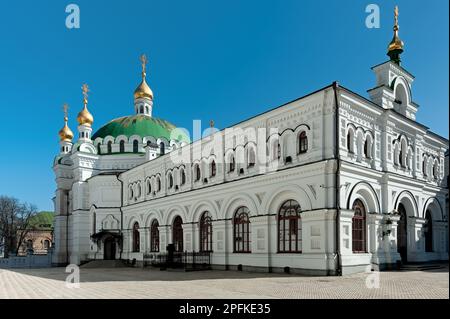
[333,81,342,276]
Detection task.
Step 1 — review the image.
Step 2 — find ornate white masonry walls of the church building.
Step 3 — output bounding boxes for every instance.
[54,53,448,275]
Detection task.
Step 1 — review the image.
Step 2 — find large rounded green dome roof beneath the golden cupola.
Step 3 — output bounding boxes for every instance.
[92,114,189,143]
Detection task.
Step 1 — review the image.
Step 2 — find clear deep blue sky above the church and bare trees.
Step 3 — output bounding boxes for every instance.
[0,0,449,210]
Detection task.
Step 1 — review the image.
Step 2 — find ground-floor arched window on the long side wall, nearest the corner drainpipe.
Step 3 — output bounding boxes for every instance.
[278,199,302,253]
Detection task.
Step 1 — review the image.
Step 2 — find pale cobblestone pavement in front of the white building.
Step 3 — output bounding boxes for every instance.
[0,266,449,299]
